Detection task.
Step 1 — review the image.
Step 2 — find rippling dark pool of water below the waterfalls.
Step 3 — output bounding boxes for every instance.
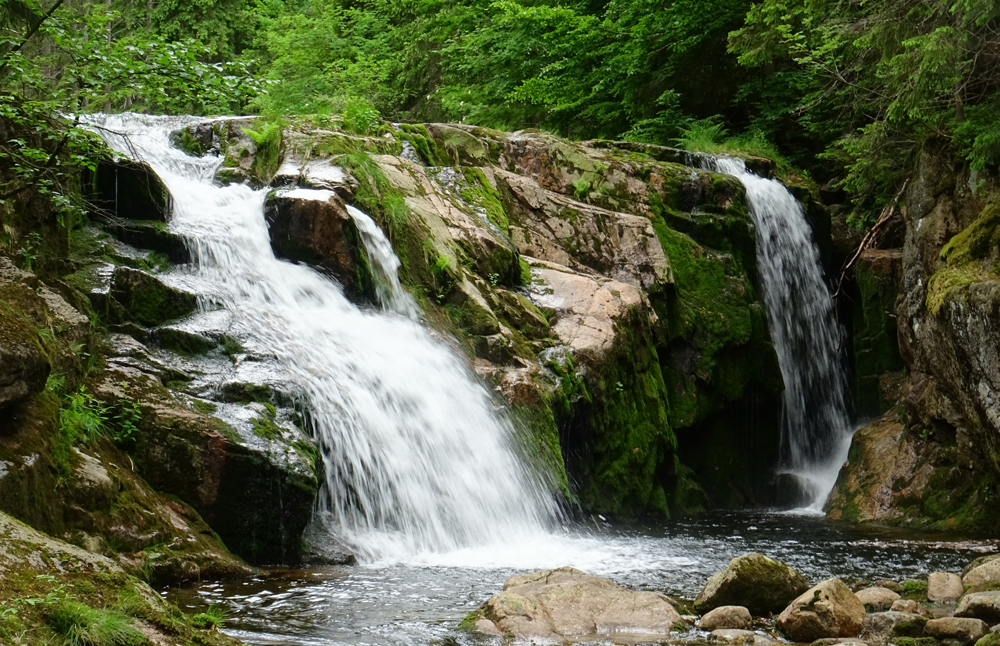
[165,513,996,646]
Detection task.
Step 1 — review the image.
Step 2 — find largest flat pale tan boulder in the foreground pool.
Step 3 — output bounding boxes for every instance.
[463,567,681,642]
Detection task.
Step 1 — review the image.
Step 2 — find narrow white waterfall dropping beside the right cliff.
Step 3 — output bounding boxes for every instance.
[693,155,853,511]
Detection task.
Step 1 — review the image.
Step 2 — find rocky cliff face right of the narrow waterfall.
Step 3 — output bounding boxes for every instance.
[828,147,1000,530]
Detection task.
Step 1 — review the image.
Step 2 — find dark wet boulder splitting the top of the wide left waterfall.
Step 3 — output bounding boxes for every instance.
[264,188,375,297]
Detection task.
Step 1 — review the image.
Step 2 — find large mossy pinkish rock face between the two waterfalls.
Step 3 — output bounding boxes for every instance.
[191,120,782,516]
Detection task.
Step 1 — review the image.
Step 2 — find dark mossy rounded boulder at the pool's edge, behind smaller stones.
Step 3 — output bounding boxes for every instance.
[694,553,809,615]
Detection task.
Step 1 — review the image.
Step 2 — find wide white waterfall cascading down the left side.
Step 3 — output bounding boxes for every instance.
[92,115,558,561]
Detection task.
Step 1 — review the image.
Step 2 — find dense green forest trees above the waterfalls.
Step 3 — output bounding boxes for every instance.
[0,0,1000,256]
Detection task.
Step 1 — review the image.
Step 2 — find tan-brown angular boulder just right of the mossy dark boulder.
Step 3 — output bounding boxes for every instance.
[776,579,865,642]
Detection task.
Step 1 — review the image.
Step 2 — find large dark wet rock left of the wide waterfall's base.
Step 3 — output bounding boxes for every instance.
[93,367,319,564]
